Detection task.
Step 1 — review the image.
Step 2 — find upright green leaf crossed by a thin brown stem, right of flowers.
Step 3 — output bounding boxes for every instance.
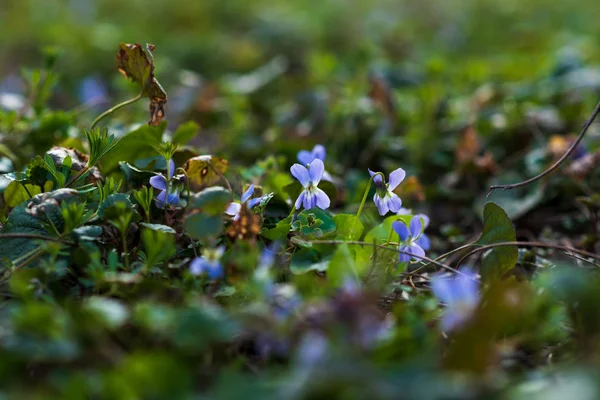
[476,202,519,280]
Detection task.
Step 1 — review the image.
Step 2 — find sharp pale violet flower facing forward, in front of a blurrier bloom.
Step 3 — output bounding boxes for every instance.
[290,158,330,210]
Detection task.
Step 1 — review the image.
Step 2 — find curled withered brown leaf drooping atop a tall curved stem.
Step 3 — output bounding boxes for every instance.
[117,43,167,126]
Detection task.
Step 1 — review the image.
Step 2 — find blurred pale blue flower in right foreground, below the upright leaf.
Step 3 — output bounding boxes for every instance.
[431,268,480,332]
